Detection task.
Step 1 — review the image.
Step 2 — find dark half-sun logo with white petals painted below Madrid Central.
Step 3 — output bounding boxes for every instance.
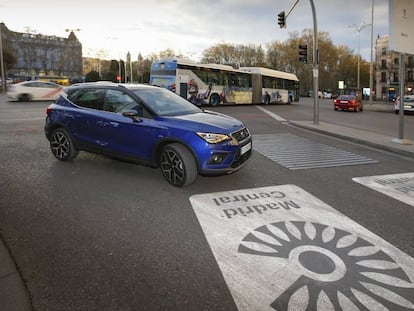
[238,221,414,310]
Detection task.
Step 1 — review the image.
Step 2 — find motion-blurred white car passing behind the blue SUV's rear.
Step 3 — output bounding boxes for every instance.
[7,80,63,101]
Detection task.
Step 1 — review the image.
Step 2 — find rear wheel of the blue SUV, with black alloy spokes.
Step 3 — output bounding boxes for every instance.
[50,128,78,161]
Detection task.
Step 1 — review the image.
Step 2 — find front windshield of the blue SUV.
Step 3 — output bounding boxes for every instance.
[134,88,201,116]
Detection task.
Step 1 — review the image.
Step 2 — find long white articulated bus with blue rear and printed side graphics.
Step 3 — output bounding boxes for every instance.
[150,59,299,106]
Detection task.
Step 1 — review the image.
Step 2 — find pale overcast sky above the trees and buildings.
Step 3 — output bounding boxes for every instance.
[0,0,389,60]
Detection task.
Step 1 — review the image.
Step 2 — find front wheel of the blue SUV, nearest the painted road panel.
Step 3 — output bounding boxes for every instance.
[160,143,198,187]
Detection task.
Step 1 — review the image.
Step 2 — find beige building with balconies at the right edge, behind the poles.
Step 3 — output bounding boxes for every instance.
[375,35,414,101]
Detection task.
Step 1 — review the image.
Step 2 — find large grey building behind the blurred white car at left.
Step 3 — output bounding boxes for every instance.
[0,23,82,78]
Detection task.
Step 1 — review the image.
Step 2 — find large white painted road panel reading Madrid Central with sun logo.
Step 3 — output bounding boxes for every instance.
[190,185,414,310]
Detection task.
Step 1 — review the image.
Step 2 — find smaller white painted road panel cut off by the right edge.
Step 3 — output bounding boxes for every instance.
[352,172,414,206]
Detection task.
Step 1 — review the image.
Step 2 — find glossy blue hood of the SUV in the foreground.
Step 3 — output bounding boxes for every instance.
[162,110,245,134]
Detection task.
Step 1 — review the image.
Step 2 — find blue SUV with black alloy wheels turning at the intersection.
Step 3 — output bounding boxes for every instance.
[45,82,252,187]
